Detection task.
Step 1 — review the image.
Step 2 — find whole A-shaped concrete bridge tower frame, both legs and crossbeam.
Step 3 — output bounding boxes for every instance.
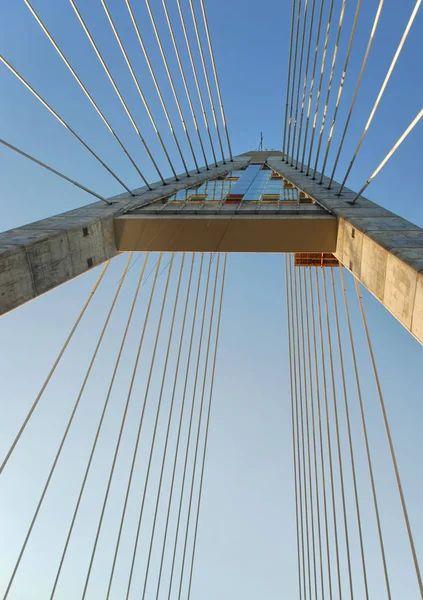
[0,151,423,342]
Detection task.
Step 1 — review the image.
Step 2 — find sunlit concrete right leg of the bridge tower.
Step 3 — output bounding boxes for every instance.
[268,157,423,343]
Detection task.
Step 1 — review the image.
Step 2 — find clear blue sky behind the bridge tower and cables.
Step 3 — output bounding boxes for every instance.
[0,0,423,600]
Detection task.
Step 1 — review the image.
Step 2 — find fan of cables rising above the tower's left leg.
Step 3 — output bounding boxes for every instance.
[0,0,233,203]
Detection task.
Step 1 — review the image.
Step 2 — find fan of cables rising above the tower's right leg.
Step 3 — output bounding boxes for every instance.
[282,0,423,203]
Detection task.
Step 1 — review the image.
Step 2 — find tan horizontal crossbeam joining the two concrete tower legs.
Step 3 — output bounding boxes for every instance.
[115,215,338,252]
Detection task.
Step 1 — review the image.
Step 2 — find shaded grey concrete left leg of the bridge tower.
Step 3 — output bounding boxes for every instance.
[0,157,249,314]
